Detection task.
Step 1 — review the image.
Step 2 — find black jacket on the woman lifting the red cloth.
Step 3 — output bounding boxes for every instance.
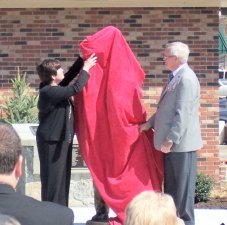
[37,57,89,141]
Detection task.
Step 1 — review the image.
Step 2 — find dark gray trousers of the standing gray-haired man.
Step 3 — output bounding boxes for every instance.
[164,151,197,225]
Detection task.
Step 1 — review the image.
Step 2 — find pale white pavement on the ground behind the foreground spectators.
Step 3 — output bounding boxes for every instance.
[72,207,227,225]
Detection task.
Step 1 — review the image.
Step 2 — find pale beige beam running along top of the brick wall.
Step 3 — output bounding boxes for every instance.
[0,0,222,8]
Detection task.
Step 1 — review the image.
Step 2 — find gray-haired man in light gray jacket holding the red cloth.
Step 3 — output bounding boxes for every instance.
[140,42,202,225]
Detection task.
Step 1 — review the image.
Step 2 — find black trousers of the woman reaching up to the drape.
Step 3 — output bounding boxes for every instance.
[37,138,72,206]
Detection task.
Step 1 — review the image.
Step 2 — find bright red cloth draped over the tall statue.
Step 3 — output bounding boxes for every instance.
[75,26,163,224]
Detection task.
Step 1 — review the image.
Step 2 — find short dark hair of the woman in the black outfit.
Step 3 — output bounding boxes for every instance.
[36,59,61,84]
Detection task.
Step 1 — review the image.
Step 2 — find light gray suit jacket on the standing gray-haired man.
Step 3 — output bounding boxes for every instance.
[150,64,202,152]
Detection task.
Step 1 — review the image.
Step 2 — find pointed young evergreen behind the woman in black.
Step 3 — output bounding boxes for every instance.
[1,67,38,123]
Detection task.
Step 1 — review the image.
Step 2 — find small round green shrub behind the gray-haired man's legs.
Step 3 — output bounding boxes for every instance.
[195,173,214,203]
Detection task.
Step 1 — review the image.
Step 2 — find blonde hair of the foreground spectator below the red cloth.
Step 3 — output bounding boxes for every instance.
[124,191,178,225]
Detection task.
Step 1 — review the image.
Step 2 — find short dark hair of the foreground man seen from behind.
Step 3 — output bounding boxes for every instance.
[0,122,22,174]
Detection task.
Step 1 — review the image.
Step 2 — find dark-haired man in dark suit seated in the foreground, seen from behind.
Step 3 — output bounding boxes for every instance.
[0,122,74,225]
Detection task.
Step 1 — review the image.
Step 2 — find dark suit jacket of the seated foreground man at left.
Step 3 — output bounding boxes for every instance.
[0,184,74,225]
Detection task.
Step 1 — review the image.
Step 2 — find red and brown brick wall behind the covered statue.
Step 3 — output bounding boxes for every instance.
[0,8,220,180]
